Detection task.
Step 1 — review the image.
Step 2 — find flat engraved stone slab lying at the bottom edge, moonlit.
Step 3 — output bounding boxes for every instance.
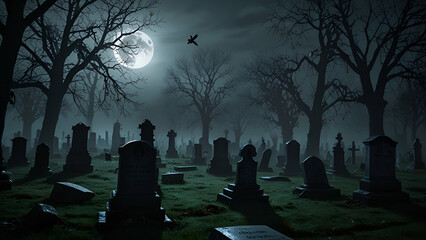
[209,225,292,240]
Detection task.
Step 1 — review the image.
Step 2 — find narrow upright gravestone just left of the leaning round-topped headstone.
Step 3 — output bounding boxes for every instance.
[280,140,303,176]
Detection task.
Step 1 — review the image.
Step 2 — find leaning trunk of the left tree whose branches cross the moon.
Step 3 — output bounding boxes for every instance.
[37,86,65,149]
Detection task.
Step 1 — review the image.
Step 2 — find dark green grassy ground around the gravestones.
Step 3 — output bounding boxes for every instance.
[0,155,426,240]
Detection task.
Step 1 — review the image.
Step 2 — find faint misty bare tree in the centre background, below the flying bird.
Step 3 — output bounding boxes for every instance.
[166,50,233,153]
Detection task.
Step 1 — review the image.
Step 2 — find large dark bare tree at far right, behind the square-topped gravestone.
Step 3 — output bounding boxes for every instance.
[334,0,426,136]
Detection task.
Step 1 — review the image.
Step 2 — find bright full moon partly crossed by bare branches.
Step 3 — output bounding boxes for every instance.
[113,31,154,69]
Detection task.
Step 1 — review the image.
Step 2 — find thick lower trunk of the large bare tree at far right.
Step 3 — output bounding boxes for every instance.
[364,96,387,136]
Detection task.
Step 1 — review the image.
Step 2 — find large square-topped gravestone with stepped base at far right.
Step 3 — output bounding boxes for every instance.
[353,136,409,206]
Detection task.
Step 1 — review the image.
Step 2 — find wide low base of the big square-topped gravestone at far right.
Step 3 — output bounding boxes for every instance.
[352,190,410,207]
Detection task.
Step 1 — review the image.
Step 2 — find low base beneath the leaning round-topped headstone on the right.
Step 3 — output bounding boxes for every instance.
[293,184,340,200]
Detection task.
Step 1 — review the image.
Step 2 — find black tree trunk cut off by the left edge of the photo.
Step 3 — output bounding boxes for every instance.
[0,0,56,160]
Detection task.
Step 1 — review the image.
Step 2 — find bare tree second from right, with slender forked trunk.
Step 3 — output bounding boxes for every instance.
[271,0,353,156]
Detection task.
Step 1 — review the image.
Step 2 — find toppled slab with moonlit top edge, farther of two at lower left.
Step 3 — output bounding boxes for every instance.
[50,182,95,203]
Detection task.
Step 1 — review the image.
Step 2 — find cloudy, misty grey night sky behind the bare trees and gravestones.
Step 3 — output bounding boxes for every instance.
[4,0,388,150]
